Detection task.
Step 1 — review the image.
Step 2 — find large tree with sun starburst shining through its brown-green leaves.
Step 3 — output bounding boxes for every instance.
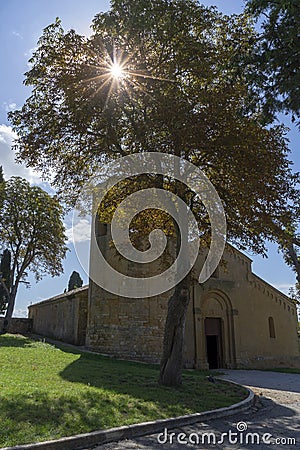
[10,0,297,385]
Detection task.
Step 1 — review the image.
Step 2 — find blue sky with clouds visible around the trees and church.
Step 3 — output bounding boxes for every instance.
[0,0,300,316]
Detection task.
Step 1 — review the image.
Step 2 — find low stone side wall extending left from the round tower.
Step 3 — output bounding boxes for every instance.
[28,286,88,345]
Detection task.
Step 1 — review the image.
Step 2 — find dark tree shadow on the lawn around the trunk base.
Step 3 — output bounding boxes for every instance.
[60,353,248,417]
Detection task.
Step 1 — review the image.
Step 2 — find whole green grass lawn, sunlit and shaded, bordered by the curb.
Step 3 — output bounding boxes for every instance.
[0,335,247,447]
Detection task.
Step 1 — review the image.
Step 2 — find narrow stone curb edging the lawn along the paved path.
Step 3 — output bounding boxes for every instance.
[0,380,255,450]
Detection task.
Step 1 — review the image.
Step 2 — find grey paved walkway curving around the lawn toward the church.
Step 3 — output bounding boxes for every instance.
[86,370,300,450]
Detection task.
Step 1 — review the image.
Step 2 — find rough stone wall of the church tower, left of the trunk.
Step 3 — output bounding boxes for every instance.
[86,224,172,363]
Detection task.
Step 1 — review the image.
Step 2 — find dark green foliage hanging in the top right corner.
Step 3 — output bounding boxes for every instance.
[247,0,300,126]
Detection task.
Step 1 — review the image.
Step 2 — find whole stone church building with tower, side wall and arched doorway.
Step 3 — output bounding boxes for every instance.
[29,225,300,369]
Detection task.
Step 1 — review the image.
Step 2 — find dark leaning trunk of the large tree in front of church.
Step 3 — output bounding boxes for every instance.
[159,275,190,386]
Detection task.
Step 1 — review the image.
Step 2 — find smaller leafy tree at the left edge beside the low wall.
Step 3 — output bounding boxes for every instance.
[0,177,66,332]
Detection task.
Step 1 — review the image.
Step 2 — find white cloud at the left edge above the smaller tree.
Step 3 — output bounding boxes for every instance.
[0,125,42,184]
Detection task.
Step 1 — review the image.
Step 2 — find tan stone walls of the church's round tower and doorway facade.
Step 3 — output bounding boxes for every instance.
[86,229,300,369]
